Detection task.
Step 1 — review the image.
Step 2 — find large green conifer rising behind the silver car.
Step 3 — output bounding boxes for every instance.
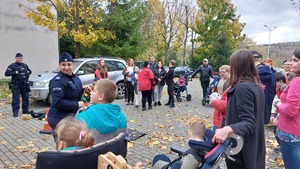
[81,0,147,59]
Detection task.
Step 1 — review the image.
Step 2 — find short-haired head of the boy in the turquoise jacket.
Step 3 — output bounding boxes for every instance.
[91,79,117,104]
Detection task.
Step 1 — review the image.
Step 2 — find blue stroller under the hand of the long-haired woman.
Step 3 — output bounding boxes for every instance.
[171,126,244,169]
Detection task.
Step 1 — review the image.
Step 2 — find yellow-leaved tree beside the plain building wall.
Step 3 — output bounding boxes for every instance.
[20,0,113,57]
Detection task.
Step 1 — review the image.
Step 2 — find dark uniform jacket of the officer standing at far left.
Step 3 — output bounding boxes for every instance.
[5,62,32,83]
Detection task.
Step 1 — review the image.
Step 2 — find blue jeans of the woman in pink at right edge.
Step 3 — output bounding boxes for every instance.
[280,141,300,169]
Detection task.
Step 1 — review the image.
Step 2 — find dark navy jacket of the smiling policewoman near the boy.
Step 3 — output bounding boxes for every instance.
[48,72,84,127]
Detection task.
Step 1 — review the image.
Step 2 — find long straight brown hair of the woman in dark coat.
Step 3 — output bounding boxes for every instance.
[230,49,259,86]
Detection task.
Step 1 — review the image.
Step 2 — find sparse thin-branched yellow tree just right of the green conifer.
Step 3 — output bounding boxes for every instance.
[147,0,184,61]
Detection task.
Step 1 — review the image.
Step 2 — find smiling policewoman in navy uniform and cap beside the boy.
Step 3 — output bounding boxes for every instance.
[48,52,84,130]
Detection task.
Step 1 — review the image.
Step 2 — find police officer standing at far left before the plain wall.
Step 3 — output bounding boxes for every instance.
[5,53,31,117]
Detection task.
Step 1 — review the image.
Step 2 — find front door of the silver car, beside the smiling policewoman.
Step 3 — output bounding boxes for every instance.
[77,60,99,85]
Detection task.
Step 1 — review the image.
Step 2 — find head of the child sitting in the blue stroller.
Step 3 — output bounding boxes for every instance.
[188,120,205,140]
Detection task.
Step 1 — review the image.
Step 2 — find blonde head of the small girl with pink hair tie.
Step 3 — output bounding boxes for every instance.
[56,116,94,150]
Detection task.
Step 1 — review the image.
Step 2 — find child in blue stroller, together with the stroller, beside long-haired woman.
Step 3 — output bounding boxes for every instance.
[152,121,244,169]
